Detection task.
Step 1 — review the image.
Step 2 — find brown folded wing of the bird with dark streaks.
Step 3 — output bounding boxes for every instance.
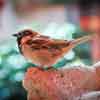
[27,36,69,49]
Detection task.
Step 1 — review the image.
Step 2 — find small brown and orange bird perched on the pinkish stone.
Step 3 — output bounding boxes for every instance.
[13,29,92,69]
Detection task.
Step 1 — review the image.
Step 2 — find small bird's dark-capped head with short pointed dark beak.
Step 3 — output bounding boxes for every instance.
[13,29,38,44]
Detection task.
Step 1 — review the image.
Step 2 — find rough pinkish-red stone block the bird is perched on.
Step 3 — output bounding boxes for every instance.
[23,67,100,100]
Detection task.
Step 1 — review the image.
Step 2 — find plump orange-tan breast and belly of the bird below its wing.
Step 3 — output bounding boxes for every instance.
[22,45,62,66]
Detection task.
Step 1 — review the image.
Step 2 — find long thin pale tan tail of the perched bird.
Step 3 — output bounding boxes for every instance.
[71,34,93,46]
